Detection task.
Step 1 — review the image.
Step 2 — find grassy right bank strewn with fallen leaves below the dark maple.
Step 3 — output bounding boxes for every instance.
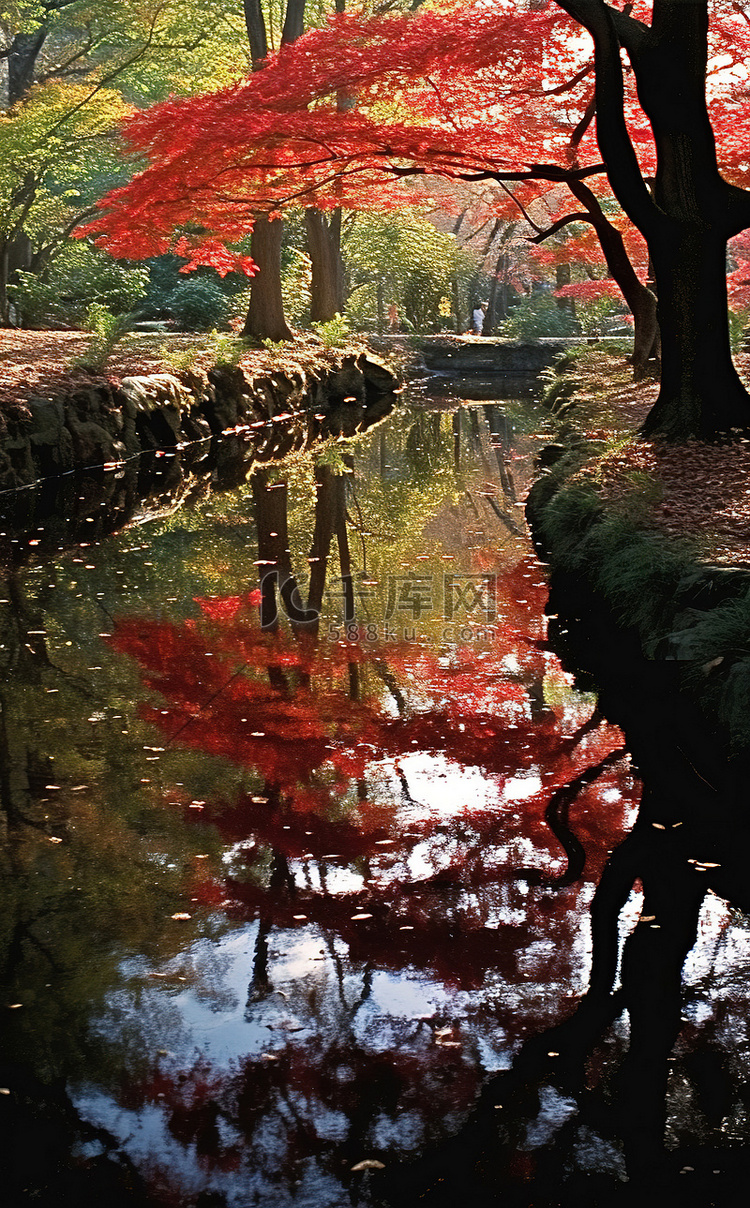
[530,352,750,754]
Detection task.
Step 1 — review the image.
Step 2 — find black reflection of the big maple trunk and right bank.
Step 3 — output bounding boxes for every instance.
[388,581,750,1206]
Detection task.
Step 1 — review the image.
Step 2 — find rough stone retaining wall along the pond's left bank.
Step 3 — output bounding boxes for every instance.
[0,353,396,490]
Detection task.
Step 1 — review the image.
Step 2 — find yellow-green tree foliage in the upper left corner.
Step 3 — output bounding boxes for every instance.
[0,0,246,324]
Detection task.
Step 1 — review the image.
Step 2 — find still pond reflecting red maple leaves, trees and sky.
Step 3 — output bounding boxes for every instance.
[0,396,750,1208]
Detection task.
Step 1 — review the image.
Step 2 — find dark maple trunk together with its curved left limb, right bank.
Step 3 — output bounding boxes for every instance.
[558,0,750,440]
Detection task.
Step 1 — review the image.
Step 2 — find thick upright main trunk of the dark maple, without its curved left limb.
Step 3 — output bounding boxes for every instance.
[635,0,750,439]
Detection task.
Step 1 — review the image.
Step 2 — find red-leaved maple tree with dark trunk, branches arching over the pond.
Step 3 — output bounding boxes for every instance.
[86,0,750,436]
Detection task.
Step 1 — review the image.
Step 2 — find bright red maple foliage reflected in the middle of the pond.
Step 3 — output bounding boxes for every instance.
[111,554,629,988]
